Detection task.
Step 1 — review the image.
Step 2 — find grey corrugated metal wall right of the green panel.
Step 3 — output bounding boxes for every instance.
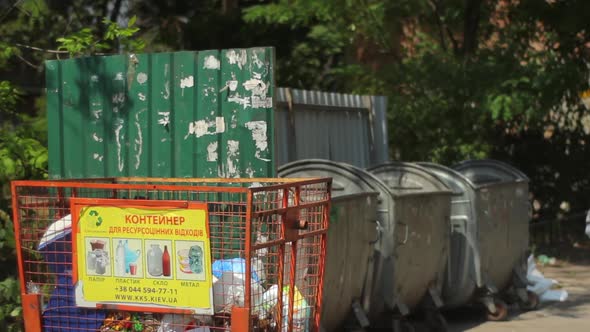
[275,88,389,168]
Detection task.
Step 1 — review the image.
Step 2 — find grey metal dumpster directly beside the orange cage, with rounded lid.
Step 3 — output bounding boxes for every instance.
[278,159,388,331]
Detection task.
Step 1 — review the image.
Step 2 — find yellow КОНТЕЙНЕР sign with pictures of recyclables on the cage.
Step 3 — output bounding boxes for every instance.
[72,199,213,314]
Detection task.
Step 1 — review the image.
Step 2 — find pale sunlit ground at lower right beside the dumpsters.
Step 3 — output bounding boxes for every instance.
[446,248,590,332]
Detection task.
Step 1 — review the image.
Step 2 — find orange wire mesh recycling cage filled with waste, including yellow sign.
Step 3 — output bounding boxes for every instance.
[12,178,331,332]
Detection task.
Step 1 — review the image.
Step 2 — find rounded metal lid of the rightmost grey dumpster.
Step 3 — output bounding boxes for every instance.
[452,159,529,186]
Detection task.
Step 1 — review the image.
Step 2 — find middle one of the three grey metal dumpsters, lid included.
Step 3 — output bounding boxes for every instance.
[369,162,451,314]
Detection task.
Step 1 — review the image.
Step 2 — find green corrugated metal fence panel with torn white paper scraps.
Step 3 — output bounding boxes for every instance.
[45,48,275,179]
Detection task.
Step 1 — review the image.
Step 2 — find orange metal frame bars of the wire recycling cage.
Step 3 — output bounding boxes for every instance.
[11,178,332,332]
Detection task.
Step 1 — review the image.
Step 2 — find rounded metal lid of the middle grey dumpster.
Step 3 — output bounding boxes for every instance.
[369,162,451,195]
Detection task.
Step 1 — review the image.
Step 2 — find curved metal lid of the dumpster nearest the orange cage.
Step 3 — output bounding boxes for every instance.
[278,159,390,197]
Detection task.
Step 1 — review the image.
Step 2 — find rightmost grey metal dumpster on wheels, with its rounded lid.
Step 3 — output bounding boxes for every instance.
[420,160,536,320]
